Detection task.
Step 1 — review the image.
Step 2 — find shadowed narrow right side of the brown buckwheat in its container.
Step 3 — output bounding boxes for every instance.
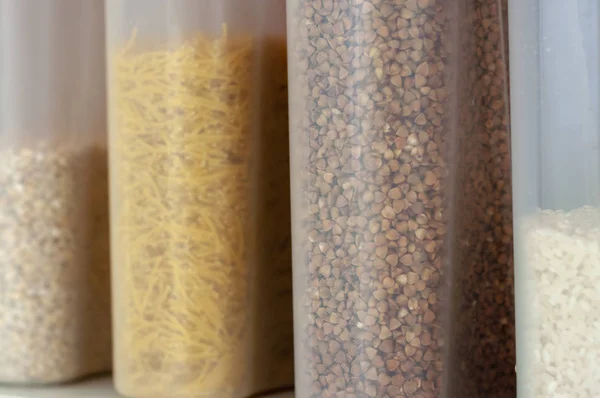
[448,0,516,398]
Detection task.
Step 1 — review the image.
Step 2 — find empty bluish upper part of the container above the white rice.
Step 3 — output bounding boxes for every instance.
[509,0,600,213]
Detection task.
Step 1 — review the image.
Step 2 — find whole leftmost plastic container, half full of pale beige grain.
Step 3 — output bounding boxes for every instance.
[0,0,111,384]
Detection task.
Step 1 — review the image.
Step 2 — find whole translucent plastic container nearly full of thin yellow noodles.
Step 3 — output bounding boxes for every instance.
[107,0,293,398]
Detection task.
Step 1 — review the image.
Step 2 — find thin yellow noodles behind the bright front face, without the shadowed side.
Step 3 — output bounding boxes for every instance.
[111,25,253,397]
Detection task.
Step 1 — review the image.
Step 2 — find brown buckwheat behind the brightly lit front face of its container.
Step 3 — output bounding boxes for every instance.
[288,0,448,397]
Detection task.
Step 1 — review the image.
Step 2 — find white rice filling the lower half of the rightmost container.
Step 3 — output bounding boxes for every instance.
[523,206,600,398]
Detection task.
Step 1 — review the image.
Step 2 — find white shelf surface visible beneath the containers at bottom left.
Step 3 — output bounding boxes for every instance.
[0,377,294,398]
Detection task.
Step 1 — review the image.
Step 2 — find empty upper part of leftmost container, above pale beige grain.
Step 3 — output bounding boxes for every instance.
[0,0,106,146]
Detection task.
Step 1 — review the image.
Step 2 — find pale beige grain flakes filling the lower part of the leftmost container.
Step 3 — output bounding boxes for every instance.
[0,145,111,384]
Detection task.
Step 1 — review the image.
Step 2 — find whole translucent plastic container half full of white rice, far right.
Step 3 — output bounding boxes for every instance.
[509,0,600,398]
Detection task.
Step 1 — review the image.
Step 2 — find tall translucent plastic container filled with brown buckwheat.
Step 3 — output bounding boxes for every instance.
[288,0,515,398]
